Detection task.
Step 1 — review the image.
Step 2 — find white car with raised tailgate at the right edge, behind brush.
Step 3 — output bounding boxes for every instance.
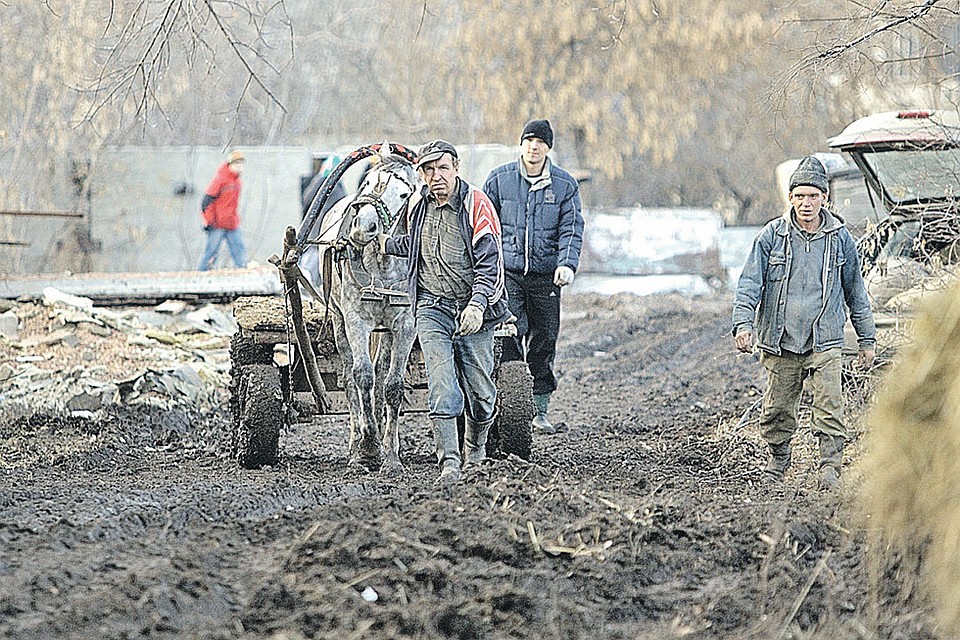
[829,109,960,356]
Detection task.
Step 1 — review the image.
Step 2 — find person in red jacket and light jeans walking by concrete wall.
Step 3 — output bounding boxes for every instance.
[197,151,247,271]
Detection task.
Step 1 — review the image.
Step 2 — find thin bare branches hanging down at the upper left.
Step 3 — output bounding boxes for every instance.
[82,0,294,140]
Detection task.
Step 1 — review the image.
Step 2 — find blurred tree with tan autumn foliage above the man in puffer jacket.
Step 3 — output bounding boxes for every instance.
[444,0,766,177]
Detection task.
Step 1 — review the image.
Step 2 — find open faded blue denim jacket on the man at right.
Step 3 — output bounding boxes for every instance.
[733,209,876,355]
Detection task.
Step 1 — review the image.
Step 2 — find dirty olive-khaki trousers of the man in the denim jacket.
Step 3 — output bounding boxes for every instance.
[760,348,847,444]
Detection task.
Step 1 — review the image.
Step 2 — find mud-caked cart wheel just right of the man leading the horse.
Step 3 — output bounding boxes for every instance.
[487,360,536,460]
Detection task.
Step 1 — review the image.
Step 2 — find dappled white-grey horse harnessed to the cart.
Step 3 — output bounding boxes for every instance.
[302,143,422,474]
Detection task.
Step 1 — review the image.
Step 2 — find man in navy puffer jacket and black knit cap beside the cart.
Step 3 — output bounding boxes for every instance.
[483,120,583,429]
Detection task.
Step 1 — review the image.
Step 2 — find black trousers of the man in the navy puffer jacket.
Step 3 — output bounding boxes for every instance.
[501,271,560,395]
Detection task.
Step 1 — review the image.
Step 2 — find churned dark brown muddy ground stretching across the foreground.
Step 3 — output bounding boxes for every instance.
[0,294,939,640]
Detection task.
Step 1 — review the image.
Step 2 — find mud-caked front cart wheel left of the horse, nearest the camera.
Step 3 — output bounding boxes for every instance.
[230,364,283,469]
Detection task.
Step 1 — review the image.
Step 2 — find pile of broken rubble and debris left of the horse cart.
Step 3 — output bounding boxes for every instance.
[0,288,236,420]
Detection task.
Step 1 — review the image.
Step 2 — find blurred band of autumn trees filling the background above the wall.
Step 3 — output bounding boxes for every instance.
[7,0,960,270]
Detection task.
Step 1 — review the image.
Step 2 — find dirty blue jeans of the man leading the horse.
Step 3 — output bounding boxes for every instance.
[417,293,497,423]
